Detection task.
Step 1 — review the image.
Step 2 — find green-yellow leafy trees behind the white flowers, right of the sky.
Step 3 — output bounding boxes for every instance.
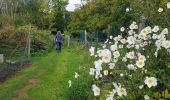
[68,0,170,35]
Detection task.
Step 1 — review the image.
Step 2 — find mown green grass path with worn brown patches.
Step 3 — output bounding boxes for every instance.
[0,48,85,100]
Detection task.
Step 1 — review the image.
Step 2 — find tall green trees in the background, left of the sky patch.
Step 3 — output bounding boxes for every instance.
[0,0,68,29]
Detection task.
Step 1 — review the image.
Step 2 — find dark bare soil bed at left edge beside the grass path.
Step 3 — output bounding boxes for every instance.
[0,60,30,83]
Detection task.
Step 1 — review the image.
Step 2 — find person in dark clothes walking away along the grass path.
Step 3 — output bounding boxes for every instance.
[55,31,64,52]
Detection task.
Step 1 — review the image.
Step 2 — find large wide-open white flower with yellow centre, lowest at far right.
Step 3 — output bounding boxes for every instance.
[144,77,157,88]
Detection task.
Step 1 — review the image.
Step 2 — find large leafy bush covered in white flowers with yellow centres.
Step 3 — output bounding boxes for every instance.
[89,3,170,100]
